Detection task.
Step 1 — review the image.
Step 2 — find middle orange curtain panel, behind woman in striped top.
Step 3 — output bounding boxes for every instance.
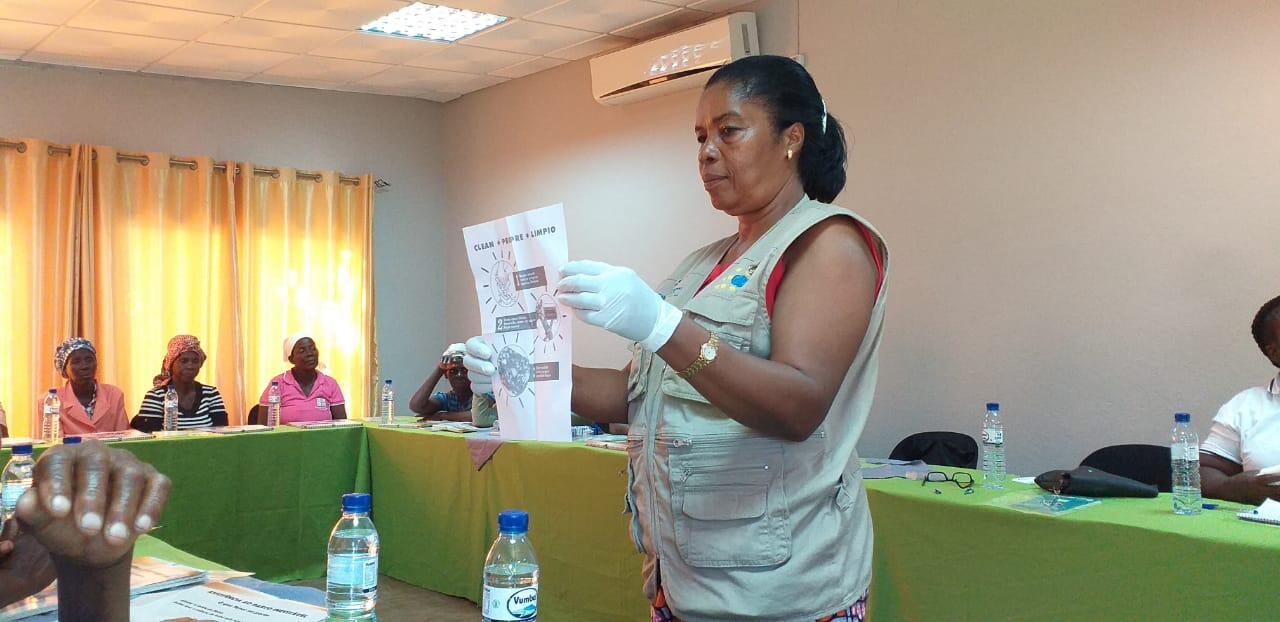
[81,147,244,422]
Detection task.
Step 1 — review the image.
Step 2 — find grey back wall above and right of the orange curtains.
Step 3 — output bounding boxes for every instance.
[0,61,447,403]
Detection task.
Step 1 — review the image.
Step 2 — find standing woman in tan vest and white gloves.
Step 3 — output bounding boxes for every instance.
[465,56,888,622]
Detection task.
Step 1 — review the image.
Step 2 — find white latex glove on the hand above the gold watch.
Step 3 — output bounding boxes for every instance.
[556,261,682,352]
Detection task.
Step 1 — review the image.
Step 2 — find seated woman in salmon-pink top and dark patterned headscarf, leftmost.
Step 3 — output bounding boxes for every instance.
[40,337,129,436]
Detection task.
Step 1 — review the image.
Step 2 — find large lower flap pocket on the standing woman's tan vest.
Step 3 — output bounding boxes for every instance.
[669,438,791,568]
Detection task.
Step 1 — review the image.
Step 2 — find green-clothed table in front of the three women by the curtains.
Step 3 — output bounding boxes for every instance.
[0,425,369,581]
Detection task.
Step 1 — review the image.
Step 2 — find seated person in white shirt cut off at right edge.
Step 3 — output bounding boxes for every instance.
[1201,296,1280,503]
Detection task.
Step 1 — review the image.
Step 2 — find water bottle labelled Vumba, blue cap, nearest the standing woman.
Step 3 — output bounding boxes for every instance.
[480,511,538,622]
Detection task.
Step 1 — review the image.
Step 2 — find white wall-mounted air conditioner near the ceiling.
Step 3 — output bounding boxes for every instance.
[591,13,760,104]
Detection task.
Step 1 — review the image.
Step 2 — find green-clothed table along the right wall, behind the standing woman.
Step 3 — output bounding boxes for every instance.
[367,426,1280,621]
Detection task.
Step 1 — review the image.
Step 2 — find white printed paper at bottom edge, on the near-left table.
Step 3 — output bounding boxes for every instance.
[129,584,325,622]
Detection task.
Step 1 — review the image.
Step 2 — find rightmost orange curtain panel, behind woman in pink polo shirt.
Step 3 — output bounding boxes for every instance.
[236,168,376,419]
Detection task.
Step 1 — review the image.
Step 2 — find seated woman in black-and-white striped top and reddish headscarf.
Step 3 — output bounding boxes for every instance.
[132,335,227,431]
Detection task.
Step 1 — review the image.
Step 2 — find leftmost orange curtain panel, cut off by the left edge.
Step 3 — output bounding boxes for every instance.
[0,140,87,436]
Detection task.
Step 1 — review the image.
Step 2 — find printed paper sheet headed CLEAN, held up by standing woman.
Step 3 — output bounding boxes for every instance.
[462,205,573,440]
